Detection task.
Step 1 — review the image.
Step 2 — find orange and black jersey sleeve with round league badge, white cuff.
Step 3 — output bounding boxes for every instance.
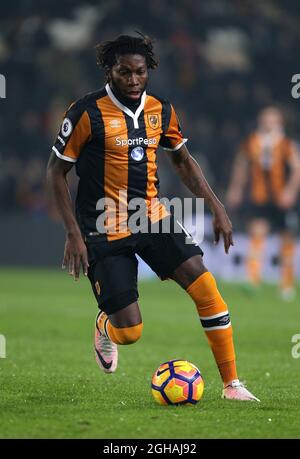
[52,102,91,163]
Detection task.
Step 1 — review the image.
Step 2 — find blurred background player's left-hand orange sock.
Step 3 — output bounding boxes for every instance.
[246,236,265,285]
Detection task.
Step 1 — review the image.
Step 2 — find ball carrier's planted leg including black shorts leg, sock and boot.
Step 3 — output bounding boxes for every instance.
[138,217,255,400]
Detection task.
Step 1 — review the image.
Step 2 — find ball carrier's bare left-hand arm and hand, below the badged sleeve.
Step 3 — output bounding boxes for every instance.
[47,151,88,280]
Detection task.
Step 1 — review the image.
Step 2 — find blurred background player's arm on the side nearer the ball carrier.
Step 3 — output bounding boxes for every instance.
[226,146,248,209]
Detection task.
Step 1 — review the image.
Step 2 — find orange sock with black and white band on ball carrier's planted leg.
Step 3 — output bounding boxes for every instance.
[187,272,237,384]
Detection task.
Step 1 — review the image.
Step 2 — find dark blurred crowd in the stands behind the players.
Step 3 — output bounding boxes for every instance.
[0,0,300,220]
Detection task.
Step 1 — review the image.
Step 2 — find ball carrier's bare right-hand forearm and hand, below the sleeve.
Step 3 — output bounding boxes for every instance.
[168,144,233,253]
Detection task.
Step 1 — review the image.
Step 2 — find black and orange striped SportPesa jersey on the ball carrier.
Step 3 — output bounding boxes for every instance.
[53,84,187,240]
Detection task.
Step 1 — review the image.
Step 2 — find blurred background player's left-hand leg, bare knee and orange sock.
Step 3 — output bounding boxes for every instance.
[246,218,270,287]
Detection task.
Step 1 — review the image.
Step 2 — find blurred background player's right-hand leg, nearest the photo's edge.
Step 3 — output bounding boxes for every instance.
[280,231,296,301]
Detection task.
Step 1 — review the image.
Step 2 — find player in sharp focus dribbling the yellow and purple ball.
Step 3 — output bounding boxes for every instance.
[47,34,258,400]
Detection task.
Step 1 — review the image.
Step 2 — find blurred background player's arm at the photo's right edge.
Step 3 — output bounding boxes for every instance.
[279,142,300,209]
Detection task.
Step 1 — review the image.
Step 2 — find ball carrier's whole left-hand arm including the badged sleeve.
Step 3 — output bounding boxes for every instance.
[47,100,91,280]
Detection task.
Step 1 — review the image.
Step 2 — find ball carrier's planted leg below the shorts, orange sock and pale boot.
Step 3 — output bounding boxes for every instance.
[171,255,258,400]
